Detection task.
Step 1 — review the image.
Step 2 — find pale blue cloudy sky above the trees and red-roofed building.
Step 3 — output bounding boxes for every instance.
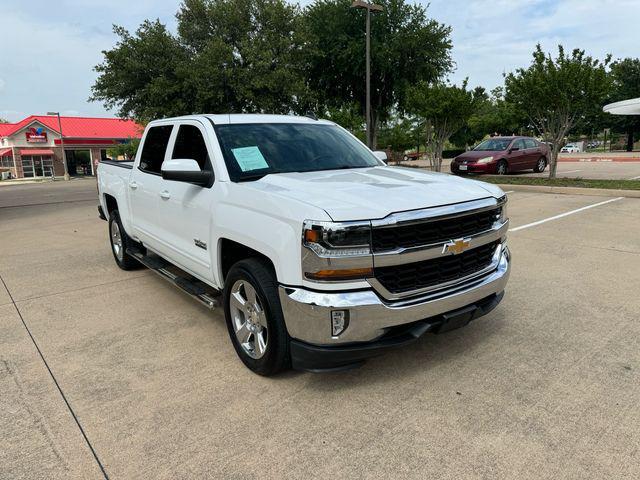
[0,0,640,121]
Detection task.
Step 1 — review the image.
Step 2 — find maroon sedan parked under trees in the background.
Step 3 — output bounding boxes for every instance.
[451,137,549,175]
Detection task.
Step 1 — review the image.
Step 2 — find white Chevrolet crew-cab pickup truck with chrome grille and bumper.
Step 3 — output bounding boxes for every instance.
[98,115,510,375]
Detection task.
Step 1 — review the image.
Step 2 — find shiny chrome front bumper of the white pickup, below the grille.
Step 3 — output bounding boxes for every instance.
[279,246,511,346]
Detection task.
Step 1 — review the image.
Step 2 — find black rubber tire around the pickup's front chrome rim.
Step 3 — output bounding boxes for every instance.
[223,258,291,376]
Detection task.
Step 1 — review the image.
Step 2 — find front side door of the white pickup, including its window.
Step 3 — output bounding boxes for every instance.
[152,120,213,280]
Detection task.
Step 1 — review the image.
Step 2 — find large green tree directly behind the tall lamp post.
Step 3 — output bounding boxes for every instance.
[302,0,452,145]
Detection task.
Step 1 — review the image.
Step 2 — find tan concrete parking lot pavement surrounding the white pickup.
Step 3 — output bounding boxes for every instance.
[0,181,640,479]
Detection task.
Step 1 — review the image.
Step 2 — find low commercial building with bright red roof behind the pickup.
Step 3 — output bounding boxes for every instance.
[0,115,144,178]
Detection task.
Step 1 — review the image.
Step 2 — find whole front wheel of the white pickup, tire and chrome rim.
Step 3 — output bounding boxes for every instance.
[223,258,290,376]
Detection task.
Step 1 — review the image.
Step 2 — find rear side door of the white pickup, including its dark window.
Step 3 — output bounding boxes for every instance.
[127,124,173,248]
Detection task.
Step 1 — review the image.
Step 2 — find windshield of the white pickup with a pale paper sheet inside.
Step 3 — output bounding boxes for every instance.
[215,123,383,182]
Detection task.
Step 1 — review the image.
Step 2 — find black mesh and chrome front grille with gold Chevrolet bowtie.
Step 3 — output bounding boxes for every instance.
[369,198,508,300]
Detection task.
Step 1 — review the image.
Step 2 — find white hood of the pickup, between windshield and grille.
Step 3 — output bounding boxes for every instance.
[252,167,502,222]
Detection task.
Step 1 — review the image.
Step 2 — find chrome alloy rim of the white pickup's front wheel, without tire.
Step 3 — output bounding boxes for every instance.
[229,280,269,359]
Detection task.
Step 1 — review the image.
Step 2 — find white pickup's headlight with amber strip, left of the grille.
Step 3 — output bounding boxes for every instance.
[302,220,373,282]
